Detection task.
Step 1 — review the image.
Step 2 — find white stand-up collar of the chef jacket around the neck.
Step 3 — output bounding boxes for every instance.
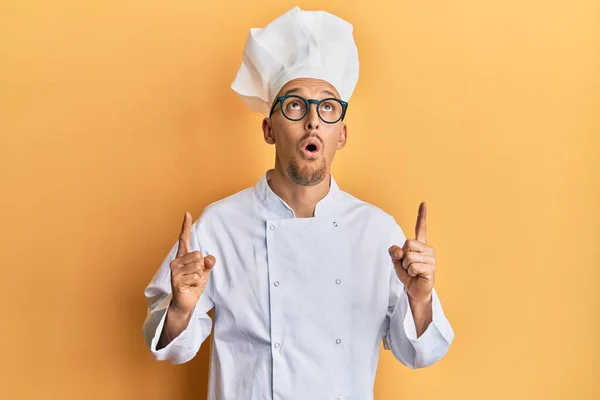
[254,169,341,218]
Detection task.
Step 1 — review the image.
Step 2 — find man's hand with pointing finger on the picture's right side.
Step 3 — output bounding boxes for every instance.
[389,202,436,302]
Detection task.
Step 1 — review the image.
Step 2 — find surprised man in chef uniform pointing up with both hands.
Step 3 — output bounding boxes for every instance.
[143,7,454,400]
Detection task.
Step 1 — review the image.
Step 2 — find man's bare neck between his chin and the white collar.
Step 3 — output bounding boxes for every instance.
[267,165,331,218]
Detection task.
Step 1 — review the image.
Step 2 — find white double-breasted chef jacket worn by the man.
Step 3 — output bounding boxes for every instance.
[143,170,454,400]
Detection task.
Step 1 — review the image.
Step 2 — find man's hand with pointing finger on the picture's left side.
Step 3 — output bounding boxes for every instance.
[169,212,217,315]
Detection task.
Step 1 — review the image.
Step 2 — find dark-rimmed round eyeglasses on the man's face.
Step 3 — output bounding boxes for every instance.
[269,94,348,124]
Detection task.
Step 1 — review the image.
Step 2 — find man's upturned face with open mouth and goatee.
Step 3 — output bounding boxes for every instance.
[262,78,347,186]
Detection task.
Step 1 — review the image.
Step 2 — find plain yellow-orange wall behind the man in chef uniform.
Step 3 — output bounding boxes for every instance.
[0,0,600,400]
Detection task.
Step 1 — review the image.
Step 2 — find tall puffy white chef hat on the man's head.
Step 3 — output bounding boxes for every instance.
[231,7,358,116]
